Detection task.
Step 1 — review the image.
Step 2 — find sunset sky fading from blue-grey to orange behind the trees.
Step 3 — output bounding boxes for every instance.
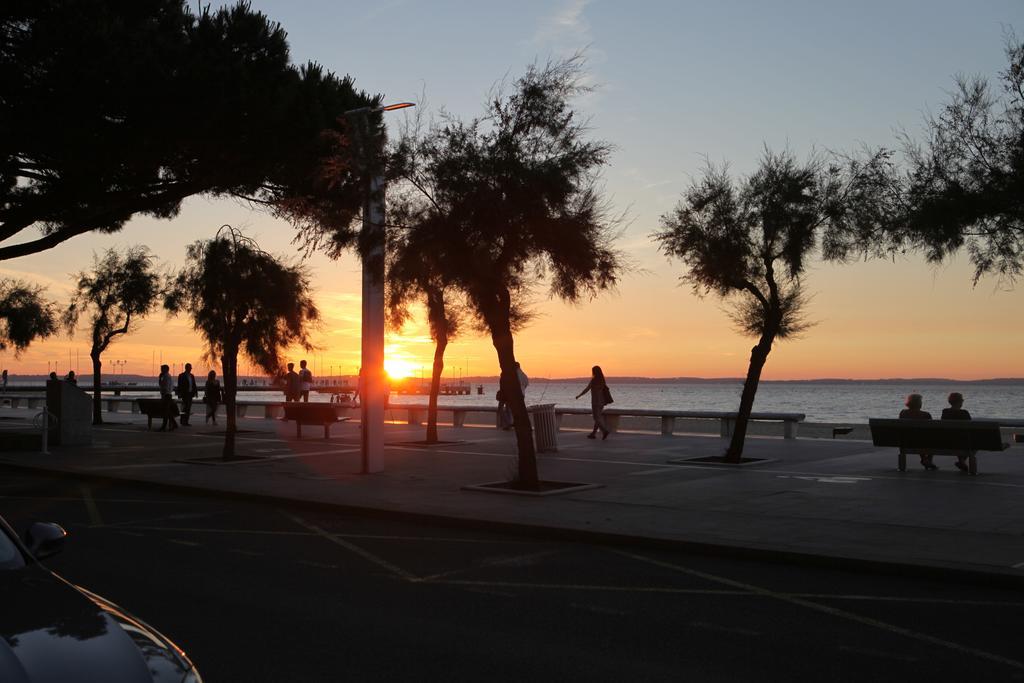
[0,0,1024,379]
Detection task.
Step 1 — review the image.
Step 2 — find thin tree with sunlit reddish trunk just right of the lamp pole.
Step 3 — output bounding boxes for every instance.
[387,232,463,443]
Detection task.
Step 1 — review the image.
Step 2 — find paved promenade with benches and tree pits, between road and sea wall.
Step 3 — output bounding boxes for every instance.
[0,409,1024,583]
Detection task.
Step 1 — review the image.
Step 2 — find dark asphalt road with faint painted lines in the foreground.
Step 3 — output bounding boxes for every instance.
[0,470,1024,683]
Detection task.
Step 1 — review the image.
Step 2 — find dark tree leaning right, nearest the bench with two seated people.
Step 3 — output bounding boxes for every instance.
[654,151,877,462]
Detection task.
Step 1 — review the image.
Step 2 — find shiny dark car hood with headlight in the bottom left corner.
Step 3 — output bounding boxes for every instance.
[0,565,190,683]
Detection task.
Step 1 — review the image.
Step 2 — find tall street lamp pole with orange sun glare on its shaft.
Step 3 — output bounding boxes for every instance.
[345,102,415,474]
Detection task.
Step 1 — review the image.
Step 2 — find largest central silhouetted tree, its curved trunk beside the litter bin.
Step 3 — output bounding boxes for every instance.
[394,57,622,487]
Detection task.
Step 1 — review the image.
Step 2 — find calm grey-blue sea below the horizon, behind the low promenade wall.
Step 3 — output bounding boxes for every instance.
[8,381,1024,423]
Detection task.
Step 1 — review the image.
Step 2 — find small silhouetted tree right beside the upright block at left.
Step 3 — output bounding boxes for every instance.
[63,247,161,425]
